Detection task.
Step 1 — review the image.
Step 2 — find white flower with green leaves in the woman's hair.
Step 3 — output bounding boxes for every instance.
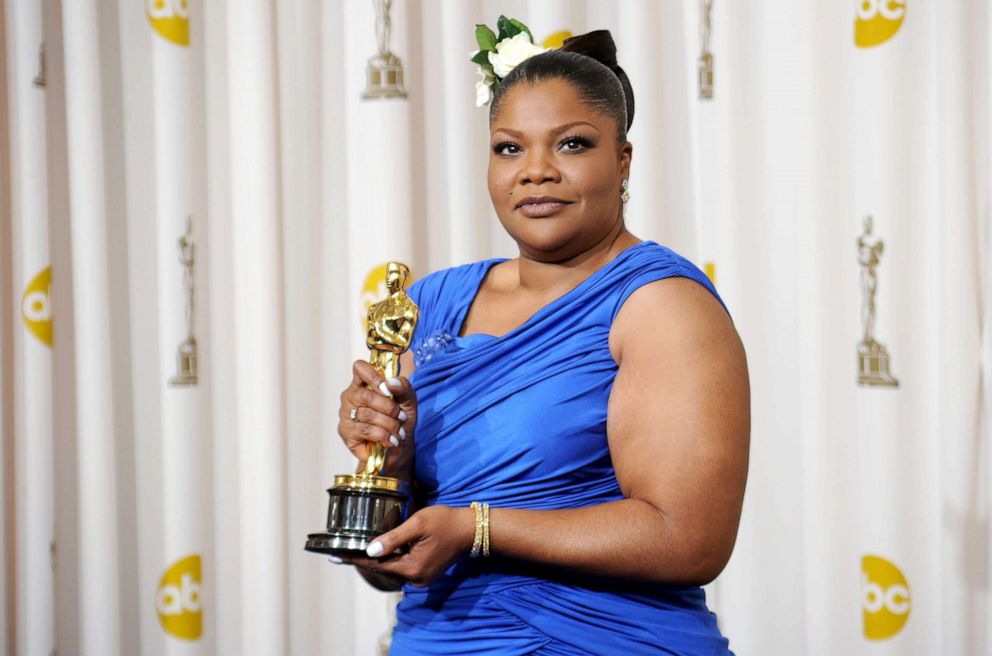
[472,16,548,107]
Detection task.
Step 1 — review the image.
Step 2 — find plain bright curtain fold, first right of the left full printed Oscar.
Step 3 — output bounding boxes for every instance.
[225,0,288,654]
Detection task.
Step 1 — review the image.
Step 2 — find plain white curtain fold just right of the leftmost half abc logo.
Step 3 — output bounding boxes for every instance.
[62,1,121,656]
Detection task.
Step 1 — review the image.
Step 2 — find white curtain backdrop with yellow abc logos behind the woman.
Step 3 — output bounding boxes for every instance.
[0,0,992,656]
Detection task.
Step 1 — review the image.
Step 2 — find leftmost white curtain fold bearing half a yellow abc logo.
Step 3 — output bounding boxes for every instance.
[5,2,55,653]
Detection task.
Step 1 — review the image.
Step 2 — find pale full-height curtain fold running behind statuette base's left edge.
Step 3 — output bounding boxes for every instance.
[276,0,331,653]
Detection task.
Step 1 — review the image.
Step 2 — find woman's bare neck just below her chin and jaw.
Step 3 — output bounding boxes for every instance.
[517,219,640,292]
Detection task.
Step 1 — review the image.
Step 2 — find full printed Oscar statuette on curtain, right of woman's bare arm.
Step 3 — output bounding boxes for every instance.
[858,216,899,387]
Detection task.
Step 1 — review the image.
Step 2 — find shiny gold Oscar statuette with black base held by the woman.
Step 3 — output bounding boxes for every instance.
[305,262,420,554]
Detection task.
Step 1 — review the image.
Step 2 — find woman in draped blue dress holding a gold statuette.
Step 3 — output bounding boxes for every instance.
[339,32,749,654]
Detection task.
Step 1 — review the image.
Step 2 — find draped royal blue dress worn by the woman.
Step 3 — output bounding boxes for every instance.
[390,242,730,656]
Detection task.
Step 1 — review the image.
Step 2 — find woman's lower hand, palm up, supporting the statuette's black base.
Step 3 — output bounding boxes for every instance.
[342,506,475,587]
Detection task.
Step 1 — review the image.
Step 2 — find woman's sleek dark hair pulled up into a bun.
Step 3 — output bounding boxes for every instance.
[489,30,634,143]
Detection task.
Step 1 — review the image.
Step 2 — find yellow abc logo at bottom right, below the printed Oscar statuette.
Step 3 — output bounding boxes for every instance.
[861,554,911,640]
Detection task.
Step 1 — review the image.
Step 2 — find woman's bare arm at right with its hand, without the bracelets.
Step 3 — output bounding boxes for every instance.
[352,278,750,584]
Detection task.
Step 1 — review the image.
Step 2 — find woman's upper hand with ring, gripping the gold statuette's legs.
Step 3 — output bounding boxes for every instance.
[338,360,417,480]
